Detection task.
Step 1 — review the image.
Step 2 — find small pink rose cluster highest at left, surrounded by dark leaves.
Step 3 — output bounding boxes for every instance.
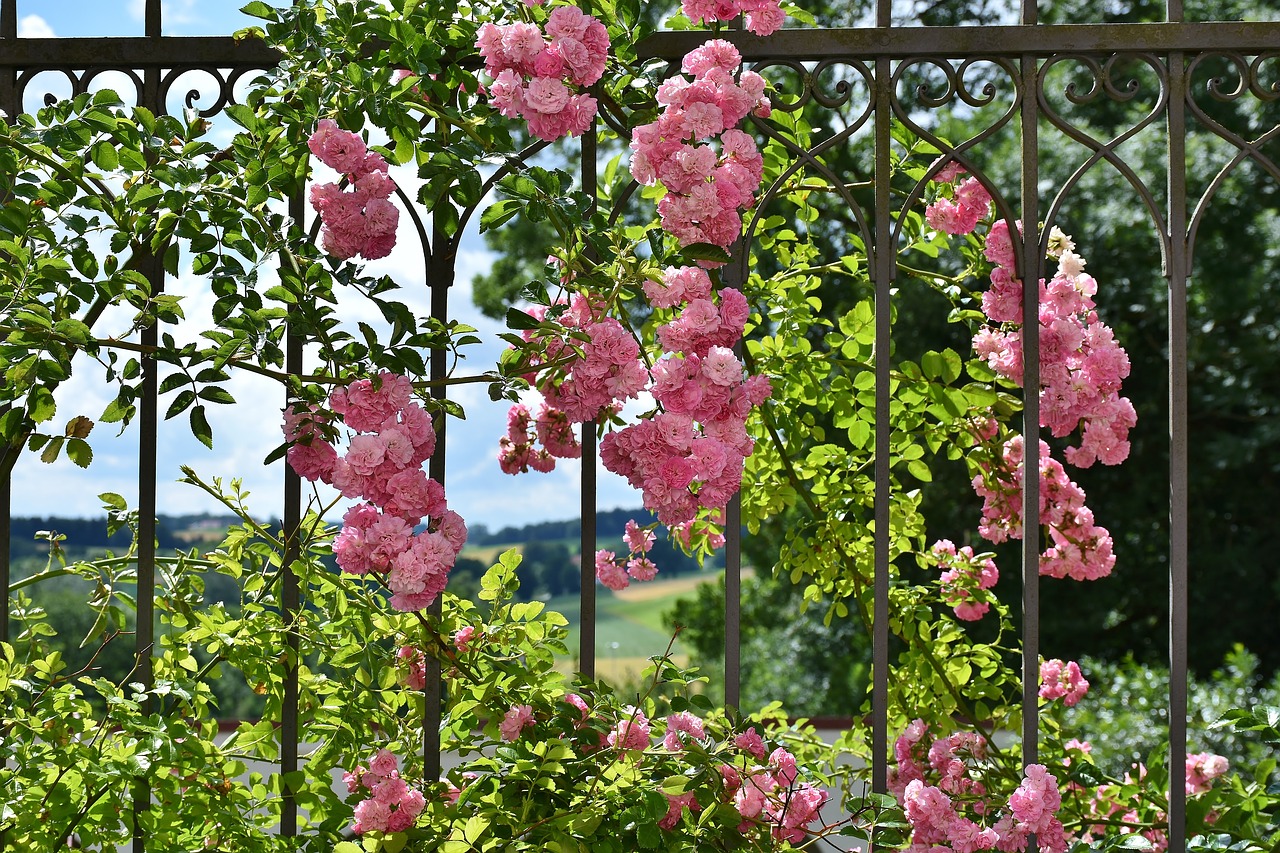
[307,119,399,260]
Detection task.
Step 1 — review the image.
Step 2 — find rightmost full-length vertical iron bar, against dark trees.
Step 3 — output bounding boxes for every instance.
[1165,44,1190,850]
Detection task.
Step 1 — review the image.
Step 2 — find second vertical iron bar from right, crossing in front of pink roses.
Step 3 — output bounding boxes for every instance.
[1020,34,1042,853]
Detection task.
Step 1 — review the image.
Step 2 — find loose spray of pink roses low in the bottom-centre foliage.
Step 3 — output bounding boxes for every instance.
[488,693,827,843]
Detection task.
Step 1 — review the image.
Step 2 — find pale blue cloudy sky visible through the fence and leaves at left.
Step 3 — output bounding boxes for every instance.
[13,0,640,528]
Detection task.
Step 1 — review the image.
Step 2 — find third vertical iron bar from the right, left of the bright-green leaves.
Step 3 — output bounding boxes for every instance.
[872,53,897,794]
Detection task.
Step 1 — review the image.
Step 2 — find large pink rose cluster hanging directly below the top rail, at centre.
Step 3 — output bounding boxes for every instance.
[631,40,771,248]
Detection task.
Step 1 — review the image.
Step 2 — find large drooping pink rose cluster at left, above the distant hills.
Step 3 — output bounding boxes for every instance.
[284,373,467,611]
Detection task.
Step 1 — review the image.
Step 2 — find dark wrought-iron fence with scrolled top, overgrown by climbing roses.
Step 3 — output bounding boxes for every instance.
[0,0,1280,850]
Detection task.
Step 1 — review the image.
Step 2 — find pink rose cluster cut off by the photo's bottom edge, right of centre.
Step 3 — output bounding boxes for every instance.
[890,720,1068,853]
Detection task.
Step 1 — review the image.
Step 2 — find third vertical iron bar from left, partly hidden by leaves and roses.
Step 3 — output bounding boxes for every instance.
[280,192,306,838]
